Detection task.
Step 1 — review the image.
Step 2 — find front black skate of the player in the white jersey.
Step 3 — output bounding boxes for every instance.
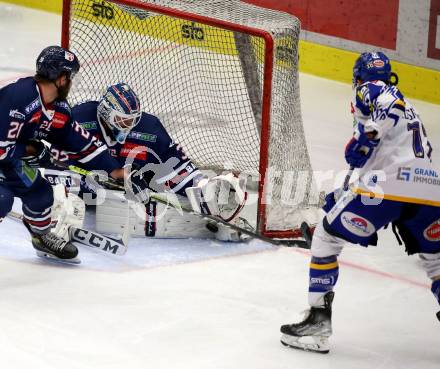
[281,291,334,354]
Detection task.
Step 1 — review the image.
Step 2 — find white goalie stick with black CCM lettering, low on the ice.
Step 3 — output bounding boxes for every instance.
[7,211,127,255]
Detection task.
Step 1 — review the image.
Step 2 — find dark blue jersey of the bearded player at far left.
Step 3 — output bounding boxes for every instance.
[0,77,119,173]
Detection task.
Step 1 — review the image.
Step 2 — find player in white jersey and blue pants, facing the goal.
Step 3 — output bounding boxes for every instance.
[281,52,440,353]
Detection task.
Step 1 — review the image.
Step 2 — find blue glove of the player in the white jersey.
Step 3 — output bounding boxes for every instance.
[345,123,379,168]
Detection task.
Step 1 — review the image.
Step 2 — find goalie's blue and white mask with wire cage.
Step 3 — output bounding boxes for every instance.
[97,83,142,144]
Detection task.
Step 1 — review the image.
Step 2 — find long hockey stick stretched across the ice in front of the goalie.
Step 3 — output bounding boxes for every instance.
[55,162,310,249]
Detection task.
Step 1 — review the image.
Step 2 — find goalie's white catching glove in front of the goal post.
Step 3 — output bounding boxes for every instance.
[185,173,247,222]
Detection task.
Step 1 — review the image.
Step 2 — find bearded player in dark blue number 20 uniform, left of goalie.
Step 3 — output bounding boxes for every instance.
[0,46,129,262]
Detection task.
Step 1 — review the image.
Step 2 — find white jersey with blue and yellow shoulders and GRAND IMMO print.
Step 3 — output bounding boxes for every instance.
[352,81,440,206]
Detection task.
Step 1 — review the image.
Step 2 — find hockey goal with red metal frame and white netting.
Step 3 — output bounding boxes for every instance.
[62,0,318,238]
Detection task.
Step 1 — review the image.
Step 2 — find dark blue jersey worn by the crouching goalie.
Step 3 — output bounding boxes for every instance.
[54,101,201,195]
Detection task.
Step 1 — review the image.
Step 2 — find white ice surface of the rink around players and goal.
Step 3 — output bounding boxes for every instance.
[0,4,440,369]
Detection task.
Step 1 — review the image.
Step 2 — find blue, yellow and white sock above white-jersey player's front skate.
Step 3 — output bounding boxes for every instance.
[309,255,339,306]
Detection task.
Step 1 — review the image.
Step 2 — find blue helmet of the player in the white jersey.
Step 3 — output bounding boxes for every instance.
[353,51,392,86]
